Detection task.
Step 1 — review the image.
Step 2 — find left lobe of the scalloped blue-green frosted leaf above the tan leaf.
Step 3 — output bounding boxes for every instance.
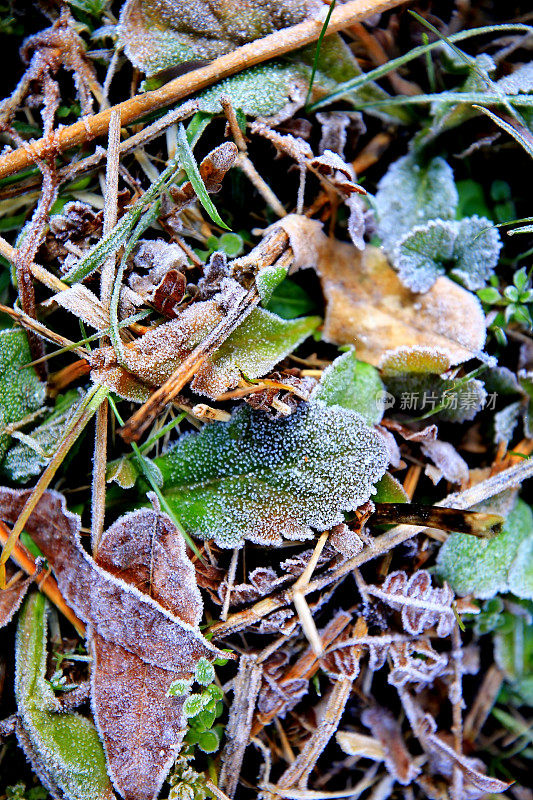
[392,219,456,292]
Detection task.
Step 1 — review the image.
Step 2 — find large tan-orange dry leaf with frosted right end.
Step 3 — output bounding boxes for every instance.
[317,240,486,365]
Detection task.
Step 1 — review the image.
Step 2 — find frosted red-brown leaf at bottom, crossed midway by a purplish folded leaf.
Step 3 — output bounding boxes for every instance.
[89,509,203,800]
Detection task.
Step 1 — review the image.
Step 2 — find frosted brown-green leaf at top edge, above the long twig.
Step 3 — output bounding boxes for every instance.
[119,0,320,75]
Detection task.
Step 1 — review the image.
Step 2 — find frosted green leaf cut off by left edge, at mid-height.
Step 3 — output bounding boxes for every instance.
[0,328,46,460]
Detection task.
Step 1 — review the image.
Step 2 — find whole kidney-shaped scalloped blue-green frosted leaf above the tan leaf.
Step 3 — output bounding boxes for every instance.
[392,216,502,292]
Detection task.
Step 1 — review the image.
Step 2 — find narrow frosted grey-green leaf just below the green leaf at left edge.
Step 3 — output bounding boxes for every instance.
[2,391,80,483]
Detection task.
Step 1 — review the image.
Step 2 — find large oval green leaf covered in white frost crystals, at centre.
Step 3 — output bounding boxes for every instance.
[156,400,388,547]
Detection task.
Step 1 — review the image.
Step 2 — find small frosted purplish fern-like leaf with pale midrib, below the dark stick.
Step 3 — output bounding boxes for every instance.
[366,569,455,637]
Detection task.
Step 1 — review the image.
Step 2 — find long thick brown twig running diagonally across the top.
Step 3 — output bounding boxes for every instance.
[0,0,405,178]
